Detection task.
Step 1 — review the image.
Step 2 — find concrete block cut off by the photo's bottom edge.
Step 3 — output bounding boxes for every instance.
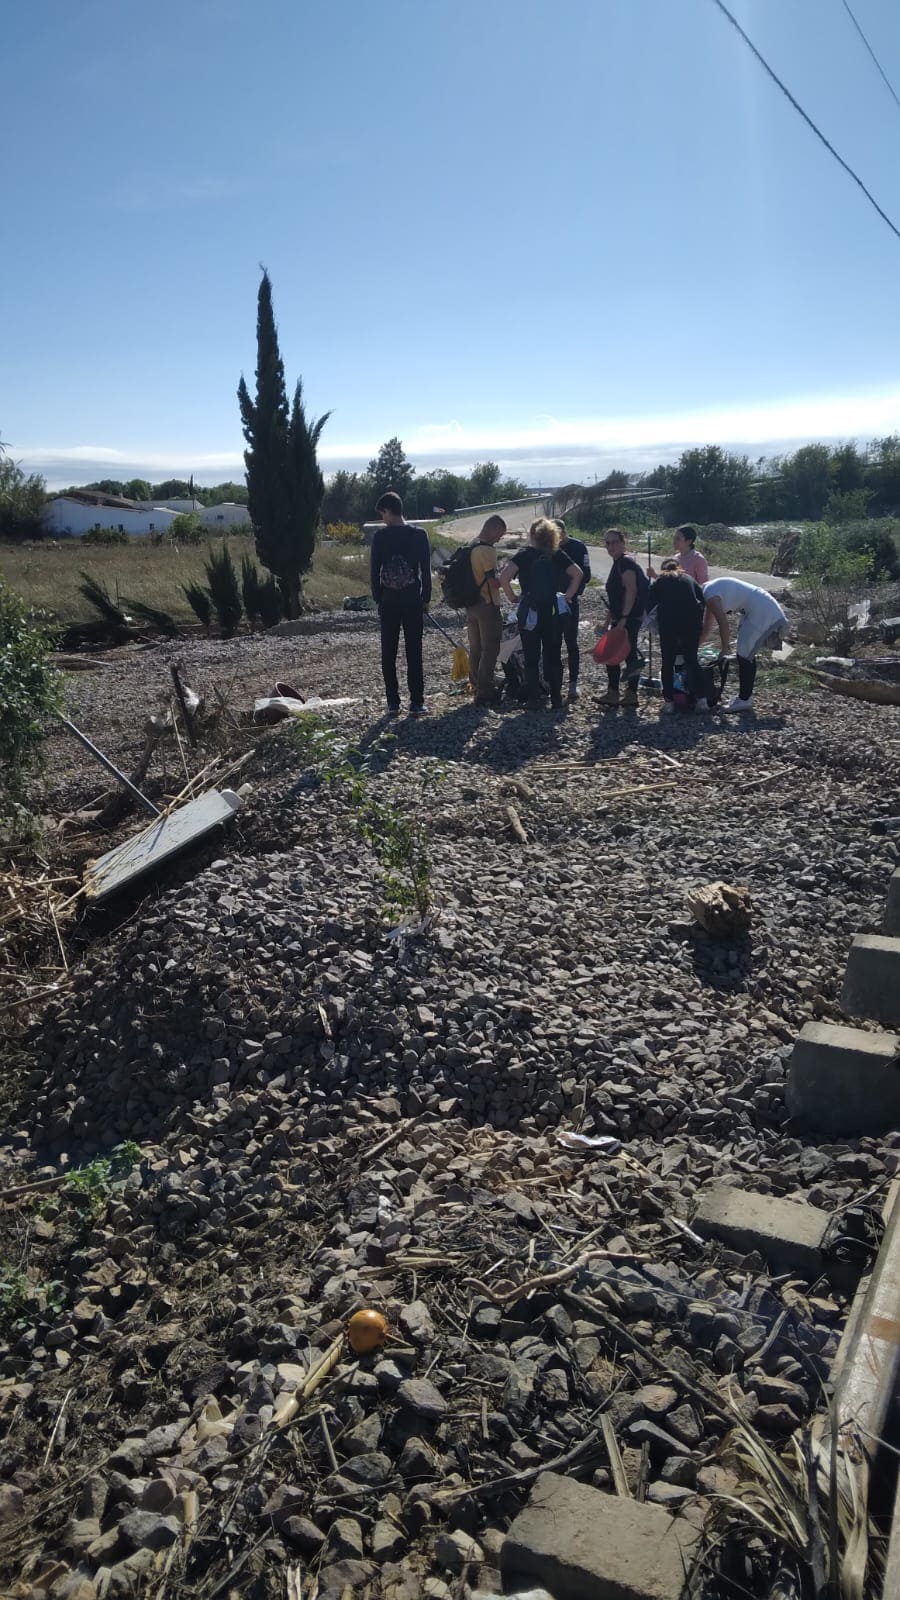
[500,1472,700,1600]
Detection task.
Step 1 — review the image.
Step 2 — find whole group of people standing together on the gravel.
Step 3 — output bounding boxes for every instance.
[372,491,788,717]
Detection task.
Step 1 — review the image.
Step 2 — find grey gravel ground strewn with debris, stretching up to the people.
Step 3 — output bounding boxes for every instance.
[0,604,900,1600]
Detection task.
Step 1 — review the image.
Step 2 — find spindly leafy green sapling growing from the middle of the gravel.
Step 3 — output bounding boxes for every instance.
[293,712,434,920]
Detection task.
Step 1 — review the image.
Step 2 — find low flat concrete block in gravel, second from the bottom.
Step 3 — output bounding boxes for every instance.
[690,1184,831,1278]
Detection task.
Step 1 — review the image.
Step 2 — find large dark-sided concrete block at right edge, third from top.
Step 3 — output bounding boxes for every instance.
[785,1022,900,1138]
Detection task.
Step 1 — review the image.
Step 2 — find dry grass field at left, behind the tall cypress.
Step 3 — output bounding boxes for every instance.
[0,534,368,624]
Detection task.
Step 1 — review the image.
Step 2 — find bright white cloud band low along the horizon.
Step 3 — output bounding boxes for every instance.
[13,387,900,488]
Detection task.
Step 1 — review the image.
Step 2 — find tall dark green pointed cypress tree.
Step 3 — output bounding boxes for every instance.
[237,272,330,618]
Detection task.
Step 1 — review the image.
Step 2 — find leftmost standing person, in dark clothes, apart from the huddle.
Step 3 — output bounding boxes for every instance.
[370,490,431,717]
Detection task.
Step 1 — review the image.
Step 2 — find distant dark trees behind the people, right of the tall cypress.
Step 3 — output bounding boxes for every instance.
[322,438,528,523]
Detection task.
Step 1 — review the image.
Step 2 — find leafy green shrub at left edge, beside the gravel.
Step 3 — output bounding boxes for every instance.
[0,579,62,832]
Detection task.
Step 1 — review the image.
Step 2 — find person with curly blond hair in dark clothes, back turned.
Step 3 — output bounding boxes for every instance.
[500,517,585,710]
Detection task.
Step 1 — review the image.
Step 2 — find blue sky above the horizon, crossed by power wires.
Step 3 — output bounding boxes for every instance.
[0,0,900,485]
